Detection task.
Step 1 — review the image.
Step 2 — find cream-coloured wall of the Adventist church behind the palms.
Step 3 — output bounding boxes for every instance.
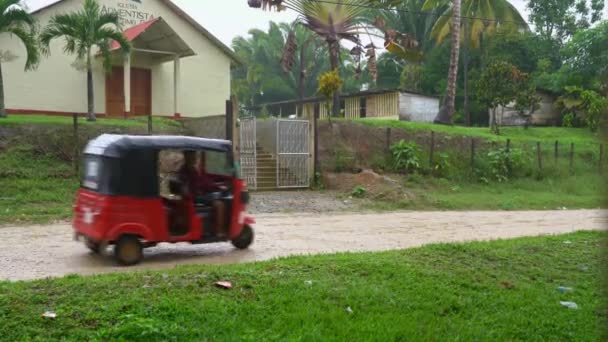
[0,0,231,117]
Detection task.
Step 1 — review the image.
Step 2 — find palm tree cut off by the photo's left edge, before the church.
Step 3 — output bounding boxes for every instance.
[0,0,40,118]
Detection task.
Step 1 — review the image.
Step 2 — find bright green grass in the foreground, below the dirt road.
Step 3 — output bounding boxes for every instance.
[0,232,608,341]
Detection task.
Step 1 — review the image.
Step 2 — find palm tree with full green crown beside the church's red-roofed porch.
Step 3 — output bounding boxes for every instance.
[40,0,131,121]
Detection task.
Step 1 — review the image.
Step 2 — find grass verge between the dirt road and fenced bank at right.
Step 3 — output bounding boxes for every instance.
[362,174,606,210]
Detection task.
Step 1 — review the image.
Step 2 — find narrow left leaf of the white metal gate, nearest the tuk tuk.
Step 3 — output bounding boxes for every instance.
[239,117,258,190]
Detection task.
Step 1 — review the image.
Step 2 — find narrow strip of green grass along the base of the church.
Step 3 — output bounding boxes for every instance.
[0,115,180,129]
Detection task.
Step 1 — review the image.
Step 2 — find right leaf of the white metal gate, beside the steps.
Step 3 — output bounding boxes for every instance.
[276,119,310,188]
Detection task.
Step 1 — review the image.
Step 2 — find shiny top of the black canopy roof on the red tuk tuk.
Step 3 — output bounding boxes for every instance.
[84,134,232,158]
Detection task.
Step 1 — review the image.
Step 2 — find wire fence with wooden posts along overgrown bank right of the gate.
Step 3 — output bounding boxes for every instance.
[319,123,606,180]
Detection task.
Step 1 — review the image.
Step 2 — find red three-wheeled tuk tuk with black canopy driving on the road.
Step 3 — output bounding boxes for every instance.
[73,134,255,265]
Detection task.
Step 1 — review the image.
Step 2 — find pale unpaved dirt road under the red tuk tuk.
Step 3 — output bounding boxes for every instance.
[0,210,608,280]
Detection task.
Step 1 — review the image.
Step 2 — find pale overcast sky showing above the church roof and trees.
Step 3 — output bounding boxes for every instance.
[26,0,608,46]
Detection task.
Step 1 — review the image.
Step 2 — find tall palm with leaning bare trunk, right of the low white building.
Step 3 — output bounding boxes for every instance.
[423,0,529,123]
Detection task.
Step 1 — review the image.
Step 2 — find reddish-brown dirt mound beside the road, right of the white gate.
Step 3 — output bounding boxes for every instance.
[323,170,413,200]
